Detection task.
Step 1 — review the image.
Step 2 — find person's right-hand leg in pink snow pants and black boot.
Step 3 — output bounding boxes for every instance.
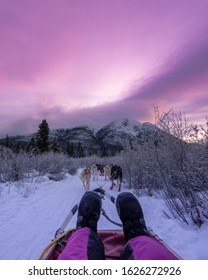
[116,192,176,260]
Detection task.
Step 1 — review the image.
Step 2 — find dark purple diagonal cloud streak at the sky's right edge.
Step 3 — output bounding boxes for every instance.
[127,36,208,101]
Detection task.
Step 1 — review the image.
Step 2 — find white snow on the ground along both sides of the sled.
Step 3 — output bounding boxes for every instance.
[0,171,208,260]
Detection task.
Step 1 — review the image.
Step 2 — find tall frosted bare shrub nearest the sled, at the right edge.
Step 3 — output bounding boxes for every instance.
[155,108,208,227]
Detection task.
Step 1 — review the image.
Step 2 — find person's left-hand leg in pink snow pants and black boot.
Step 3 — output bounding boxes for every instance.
[58,191,105,260]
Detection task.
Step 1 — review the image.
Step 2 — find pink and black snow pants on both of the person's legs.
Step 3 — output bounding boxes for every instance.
[58,227,177,260]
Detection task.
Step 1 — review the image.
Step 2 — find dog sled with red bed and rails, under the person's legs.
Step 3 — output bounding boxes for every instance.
[39,188,182,260]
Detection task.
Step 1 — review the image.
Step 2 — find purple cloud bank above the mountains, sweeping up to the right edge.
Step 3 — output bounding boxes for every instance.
[0,34,208,136]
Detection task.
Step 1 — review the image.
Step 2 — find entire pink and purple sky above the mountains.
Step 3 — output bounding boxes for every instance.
[0,0,208,137]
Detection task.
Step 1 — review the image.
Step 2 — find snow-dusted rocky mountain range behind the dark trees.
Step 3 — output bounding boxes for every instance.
[1,119,158,152]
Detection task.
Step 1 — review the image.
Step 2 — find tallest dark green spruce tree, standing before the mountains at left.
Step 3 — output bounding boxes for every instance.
[37,119,50,153]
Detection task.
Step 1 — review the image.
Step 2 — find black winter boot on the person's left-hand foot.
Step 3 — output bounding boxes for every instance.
[76,191,102,233]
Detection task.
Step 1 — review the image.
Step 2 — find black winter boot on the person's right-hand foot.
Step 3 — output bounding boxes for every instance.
[116,192,148,242]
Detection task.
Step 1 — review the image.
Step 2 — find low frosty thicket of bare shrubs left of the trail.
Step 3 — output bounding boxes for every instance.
[0,147,80,197]
